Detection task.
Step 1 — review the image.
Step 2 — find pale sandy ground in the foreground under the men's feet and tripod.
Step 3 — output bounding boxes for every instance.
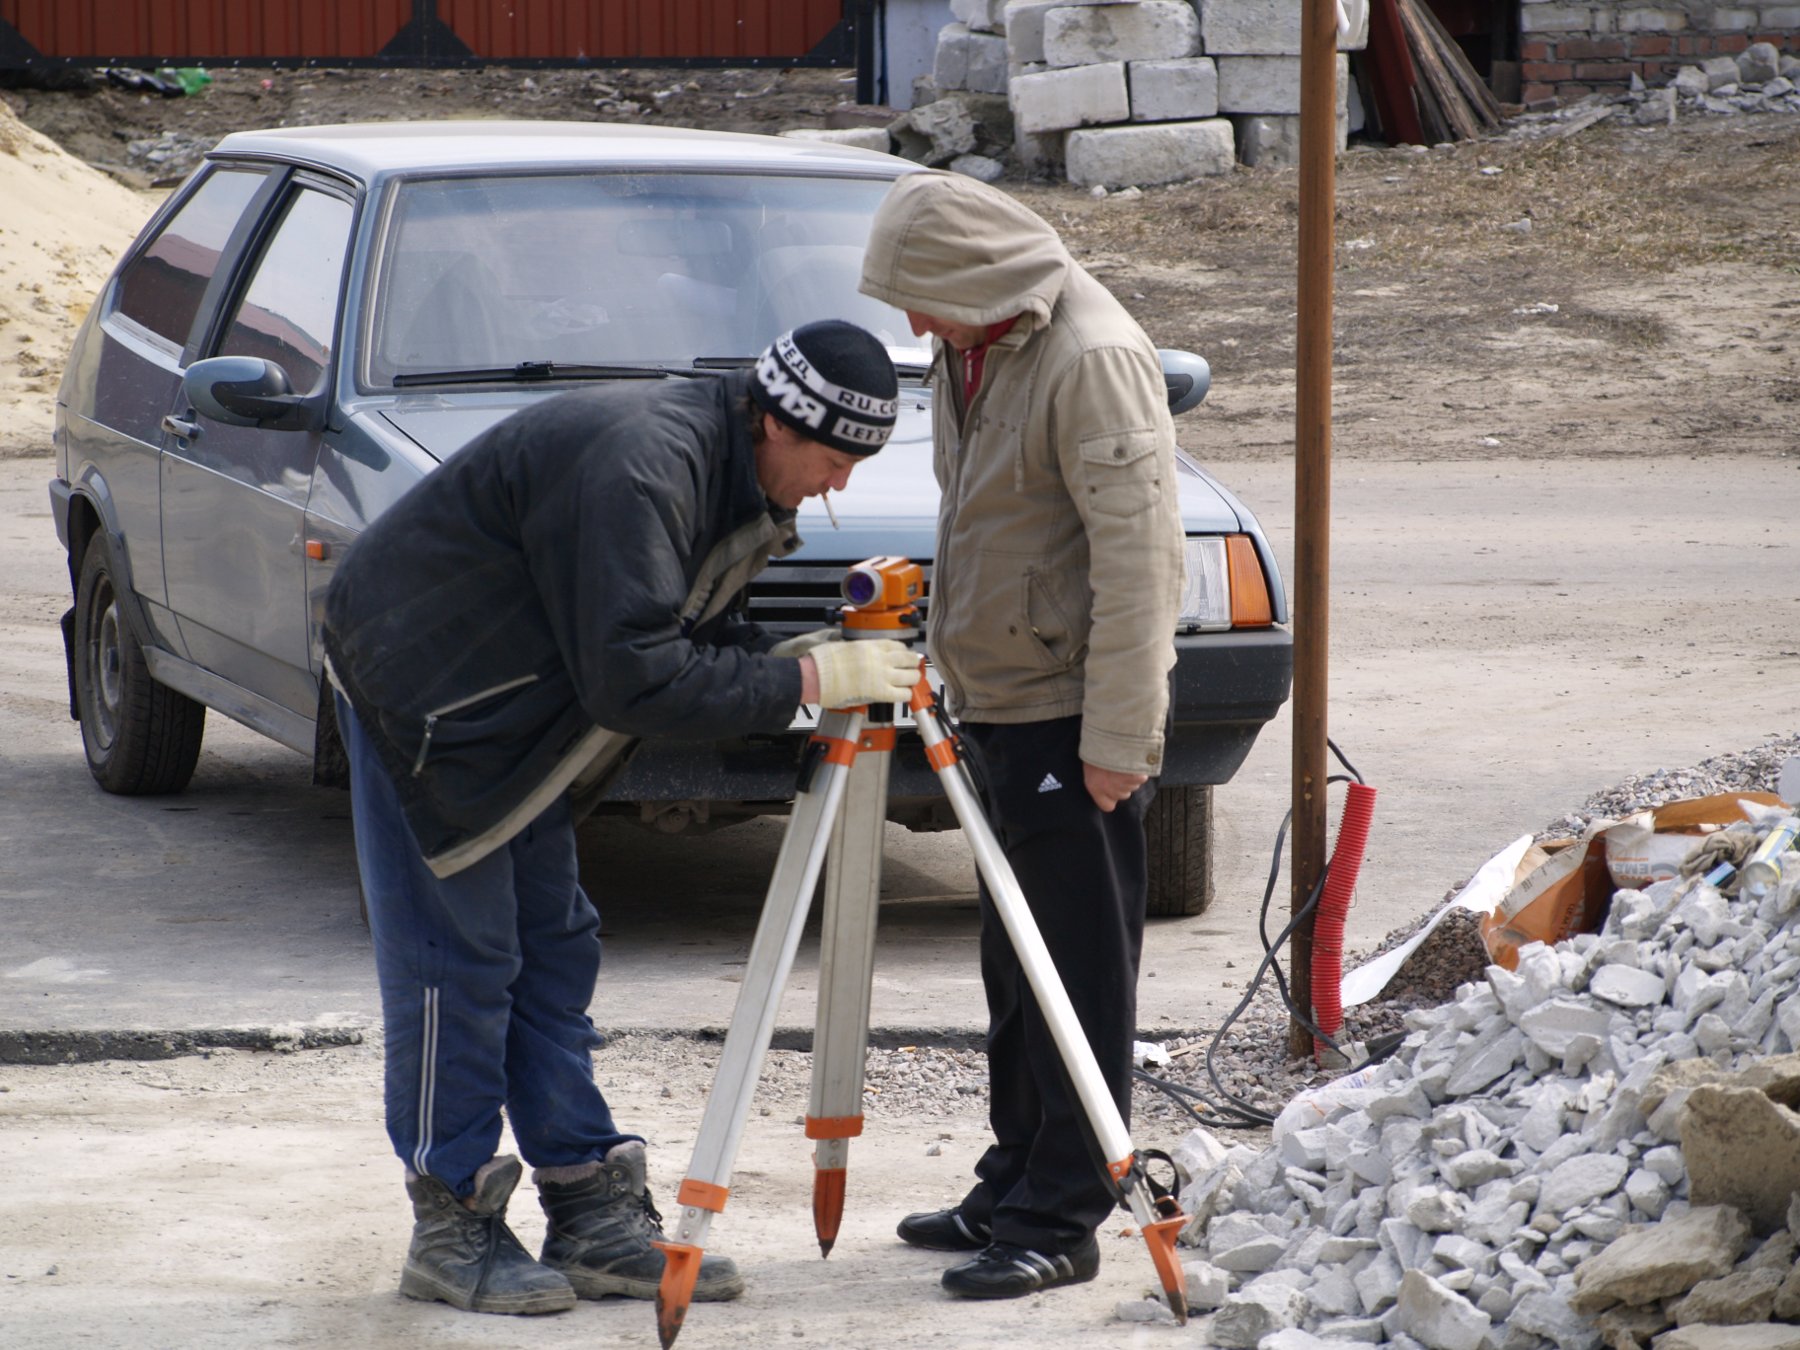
[0,1039,1180,1350]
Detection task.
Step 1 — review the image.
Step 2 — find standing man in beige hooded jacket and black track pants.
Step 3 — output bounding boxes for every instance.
[862,173,1183,1298]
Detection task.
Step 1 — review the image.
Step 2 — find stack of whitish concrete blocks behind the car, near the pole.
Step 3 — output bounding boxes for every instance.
[932,0,1368,187]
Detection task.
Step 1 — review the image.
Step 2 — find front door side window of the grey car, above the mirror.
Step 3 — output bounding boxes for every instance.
[218,187,353,394]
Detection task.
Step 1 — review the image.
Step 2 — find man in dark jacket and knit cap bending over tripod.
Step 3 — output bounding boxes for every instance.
[326,320,918,1312]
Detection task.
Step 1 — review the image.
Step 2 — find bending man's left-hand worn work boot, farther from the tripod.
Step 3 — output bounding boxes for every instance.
[400,1157,574,1314]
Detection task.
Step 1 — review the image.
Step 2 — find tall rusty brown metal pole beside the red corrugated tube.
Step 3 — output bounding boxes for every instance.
[1287,0,1337,1057]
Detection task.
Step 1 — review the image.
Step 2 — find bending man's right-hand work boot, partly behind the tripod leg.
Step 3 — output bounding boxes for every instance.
[531,1139,743,1303]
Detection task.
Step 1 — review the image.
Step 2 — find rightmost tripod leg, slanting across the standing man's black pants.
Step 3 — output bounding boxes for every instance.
[913,684,1188,1321]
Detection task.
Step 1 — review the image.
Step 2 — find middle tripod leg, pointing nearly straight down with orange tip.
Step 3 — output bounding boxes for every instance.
[806,725,895,1256]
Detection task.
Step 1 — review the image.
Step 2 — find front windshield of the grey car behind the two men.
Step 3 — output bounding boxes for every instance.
[365,173,931,387]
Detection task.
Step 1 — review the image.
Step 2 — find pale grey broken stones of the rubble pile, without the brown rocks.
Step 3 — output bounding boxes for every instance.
[1181,810,1800,1350]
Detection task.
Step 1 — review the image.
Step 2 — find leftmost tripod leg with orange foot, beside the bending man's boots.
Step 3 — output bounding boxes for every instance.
[657,709,862,1350]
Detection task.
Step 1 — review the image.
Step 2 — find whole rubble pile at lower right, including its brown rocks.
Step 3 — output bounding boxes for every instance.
[1159,808,1800,1350]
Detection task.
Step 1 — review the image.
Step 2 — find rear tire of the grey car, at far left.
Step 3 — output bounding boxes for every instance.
[76,536,207,796]
